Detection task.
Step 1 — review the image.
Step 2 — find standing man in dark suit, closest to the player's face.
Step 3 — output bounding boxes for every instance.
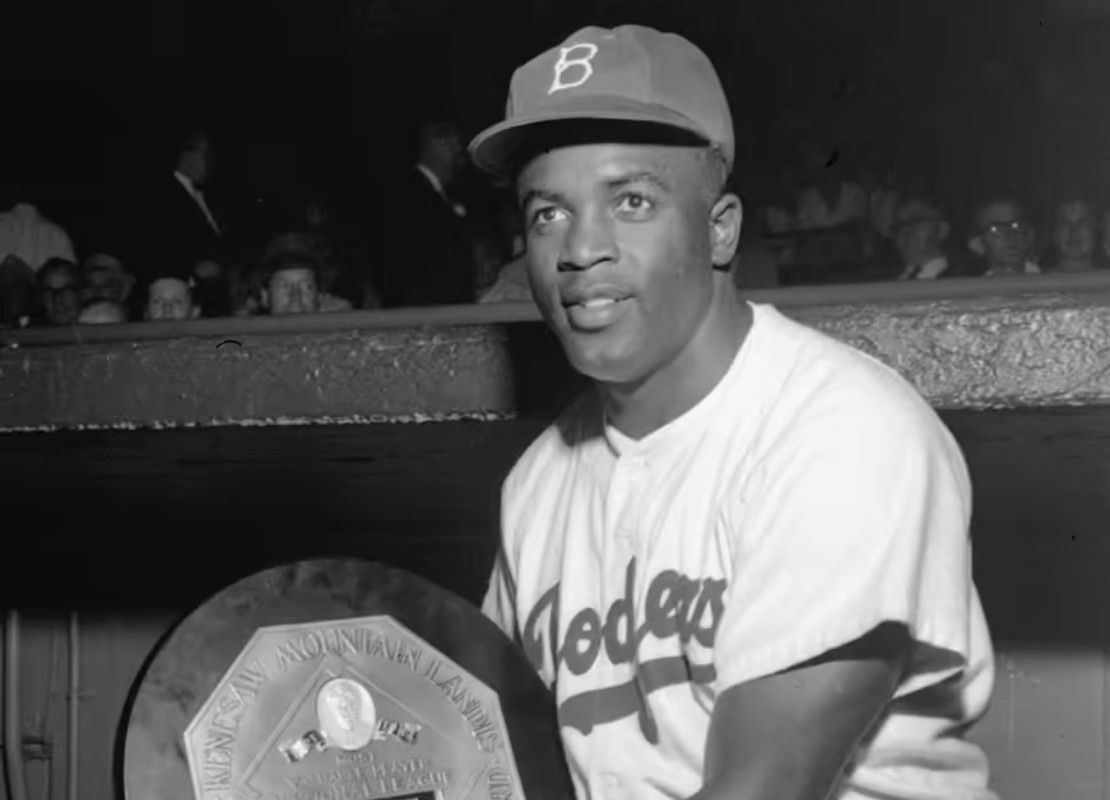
[374,123,474,307]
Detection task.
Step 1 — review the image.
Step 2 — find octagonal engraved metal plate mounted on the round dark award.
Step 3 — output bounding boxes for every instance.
[184,616,524,800]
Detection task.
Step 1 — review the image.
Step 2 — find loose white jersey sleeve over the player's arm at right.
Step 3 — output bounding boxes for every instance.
[714,404,973,695]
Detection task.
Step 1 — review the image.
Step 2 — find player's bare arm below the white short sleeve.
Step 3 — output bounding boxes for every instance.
[693,624,912,800]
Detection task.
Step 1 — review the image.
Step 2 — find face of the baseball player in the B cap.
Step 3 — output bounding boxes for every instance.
[517,144,714,384]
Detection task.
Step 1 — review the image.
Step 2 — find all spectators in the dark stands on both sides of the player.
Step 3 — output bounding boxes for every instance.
[0,128,1110,328]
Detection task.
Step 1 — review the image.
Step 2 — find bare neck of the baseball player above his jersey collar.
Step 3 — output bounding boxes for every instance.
[599,280,751,439]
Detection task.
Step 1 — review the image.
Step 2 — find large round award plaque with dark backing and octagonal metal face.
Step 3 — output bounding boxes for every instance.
[122,559,573,800]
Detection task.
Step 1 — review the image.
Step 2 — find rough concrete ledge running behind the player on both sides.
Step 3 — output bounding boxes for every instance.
[0,272,1110,432]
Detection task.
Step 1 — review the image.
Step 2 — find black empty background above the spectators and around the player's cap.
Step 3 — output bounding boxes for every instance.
[0,0,1110,243]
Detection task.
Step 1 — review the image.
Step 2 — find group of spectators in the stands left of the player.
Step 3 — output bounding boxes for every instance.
[0,122,522,328]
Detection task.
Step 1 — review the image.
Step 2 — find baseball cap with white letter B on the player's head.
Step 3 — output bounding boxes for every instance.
[470,26,736,174]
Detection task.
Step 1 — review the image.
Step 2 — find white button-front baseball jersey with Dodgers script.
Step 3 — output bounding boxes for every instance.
[483,304,996,800]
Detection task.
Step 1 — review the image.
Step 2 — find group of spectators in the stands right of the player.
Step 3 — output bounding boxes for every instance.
[759,145,1110,285]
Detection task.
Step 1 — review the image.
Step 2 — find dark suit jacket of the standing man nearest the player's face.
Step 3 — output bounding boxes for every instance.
[373,169,475,308]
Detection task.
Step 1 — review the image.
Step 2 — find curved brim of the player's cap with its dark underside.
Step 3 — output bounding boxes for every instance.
[468,94,710,175]
